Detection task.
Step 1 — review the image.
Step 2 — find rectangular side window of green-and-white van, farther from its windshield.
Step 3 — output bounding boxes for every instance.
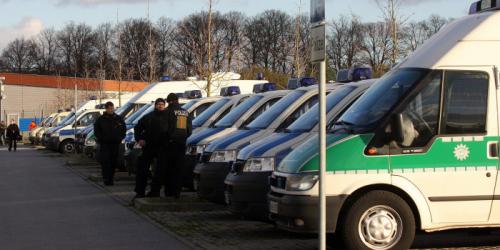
[441,71,489,135]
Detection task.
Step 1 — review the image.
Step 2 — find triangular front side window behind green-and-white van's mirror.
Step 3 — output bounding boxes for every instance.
[400,72,442,147]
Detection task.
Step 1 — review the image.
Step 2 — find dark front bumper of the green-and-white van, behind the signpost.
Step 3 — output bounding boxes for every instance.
[268,192,348,233]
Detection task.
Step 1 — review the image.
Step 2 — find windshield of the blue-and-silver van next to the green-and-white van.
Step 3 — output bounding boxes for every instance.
[285,86,356,133]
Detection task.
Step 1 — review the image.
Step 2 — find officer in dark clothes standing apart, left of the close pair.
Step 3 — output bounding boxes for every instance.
[94,102,127,186]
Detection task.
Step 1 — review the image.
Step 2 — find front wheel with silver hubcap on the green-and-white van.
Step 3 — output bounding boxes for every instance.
[341,191,415,250]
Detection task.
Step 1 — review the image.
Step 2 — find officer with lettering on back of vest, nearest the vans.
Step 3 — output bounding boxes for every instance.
[165,94,192,198]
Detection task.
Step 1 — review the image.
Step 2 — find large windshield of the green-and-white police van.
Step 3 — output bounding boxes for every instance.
[334,68,431,130]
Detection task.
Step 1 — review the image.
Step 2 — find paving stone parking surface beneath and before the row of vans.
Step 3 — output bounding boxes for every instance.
[58,147,500,250]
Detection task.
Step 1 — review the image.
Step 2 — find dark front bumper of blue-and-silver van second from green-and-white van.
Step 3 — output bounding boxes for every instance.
[193,162,231,203]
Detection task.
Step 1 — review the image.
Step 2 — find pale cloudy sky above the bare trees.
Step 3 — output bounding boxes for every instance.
[0,0,473,49]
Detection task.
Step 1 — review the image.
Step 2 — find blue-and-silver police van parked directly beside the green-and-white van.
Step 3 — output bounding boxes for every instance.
[224,80,374,219]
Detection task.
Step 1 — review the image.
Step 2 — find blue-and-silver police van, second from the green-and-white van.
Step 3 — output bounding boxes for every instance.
[194,84,338,203]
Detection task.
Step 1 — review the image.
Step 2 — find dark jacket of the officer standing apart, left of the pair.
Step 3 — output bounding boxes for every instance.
[94,113,127,144]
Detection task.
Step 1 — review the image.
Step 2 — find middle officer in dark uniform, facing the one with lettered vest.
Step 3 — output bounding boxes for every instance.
[134,98,168,198]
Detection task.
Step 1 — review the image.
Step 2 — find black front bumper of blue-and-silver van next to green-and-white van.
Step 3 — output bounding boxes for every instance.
[225,172,272,220]
